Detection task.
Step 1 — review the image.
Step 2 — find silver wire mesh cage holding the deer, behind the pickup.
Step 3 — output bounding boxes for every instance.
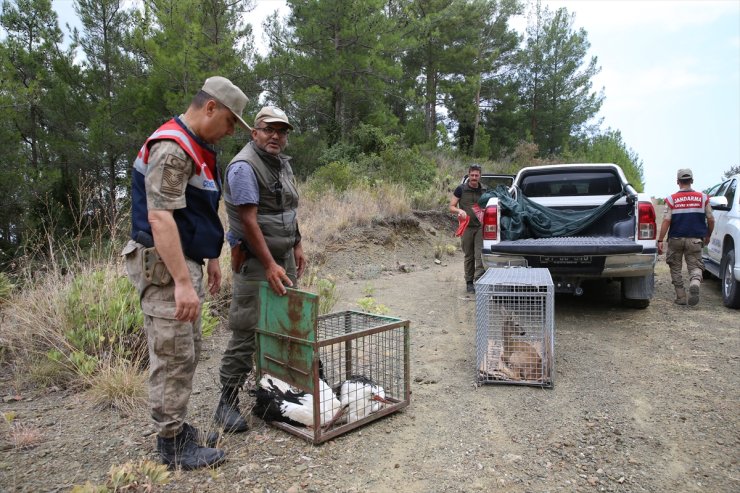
[475,267,555,388]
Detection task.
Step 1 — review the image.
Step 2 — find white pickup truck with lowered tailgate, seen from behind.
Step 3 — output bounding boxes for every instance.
[483,164,658,308]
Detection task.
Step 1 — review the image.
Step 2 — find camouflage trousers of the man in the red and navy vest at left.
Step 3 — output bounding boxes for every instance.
[123,241,205,438]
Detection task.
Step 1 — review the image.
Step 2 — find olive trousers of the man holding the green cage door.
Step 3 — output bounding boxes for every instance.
[219,249,297,387]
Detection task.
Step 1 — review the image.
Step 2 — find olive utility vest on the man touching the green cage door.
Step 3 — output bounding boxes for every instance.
[224,142,298,259]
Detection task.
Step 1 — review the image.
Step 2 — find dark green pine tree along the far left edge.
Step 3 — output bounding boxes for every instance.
[0,0,83,259]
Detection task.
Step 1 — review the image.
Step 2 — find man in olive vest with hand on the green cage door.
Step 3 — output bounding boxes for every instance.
[214,106,306,432]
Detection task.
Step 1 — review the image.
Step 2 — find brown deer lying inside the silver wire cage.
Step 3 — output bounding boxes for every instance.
[501,307,542,380]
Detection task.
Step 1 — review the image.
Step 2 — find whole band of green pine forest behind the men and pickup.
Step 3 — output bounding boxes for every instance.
[0,0,642,268]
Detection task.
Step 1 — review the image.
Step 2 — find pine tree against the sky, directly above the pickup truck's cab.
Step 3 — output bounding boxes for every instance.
[519,1,604,156]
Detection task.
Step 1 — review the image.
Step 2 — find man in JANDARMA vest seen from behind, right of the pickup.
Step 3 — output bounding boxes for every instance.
[658,168,714,306]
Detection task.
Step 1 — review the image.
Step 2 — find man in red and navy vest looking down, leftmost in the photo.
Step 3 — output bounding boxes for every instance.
[123,77,248,469]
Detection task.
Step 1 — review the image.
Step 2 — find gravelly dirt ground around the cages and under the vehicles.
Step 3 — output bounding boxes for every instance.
[0,215,740,493]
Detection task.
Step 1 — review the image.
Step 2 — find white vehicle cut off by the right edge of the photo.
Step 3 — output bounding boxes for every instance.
[703,175,740,308]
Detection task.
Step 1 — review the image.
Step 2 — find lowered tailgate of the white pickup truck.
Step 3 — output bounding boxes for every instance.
[489,236,642,257]
